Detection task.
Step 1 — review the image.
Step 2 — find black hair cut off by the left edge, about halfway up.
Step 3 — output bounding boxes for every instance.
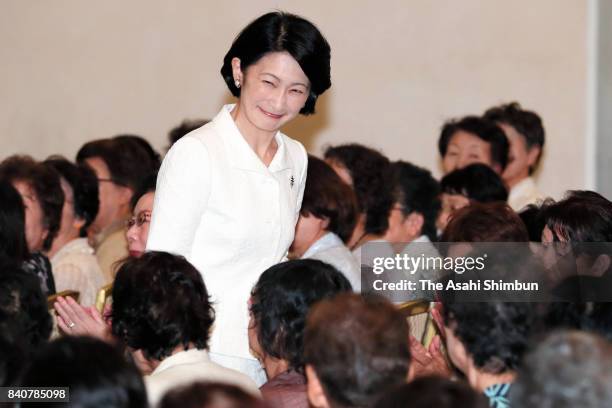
[0,181,29,265]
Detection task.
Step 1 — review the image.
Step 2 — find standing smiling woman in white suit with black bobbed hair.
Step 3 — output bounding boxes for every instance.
[147,12,331,383]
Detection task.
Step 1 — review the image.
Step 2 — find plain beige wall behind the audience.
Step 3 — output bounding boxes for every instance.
[0,0,594,196]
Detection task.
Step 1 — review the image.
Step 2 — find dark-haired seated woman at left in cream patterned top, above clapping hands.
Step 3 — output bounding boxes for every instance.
[43,156,109,306]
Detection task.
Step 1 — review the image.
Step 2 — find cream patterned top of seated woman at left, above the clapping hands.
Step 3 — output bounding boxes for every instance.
[51,238,107,306]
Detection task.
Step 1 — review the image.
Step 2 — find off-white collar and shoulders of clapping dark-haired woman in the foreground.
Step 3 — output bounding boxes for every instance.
[144,349,261,407]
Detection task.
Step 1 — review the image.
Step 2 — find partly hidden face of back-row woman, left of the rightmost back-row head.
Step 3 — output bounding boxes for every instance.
[442,130,494,174]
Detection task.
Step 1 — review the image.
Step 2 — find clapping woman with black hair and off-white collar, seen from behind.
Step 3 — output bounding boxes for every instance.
[56,252,259,406]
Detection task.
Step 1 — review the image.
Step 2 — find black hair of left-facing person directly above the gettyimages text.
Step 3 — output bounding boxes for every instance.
[391,161,441,241]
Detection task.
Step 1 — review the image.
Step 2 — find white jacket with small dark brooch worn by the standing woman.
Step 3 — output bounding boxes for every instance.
[147,105,307,359]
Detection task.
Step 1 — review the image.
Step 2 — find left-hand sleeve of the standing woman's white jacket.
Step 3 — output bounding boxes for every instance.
[147,137,210,257]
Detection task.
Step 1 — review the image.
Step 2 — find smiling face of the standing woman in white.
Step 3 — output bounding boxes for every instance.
[232,52,310,135]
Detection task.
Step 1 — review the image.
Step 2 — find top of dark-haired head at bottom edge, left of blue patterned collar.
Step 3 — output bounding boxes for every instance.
[374,377,489,408]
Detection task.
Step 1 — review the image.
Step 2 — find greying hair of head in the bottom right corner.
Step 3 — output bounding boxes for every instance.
[510,331,612,408]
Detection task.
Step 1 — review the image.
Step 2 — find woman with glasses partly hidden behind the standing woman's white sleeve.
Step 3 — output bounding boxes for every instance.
[125,173,157,258]
